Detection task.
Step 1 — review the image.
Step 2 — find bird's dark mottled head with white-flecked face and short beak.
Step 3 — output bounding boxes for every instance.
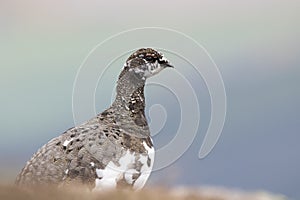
[121,48,173,80]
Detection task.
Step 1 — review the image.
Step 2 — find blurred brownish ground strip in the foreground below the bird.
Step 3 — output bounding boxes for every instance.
[0,185,286,200]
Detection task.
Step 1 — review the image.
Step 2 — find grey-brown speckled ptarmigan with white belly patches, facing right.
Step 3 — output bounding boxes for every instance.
[15,48,173,191]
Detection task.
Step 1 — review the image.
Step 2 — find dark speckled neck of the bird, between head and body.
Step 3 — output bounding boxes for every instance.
[112,69,150,137]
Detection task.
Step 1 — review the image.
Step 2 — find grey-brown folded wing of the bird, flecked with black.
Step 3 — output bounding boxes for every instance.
[16,120,121,188]
